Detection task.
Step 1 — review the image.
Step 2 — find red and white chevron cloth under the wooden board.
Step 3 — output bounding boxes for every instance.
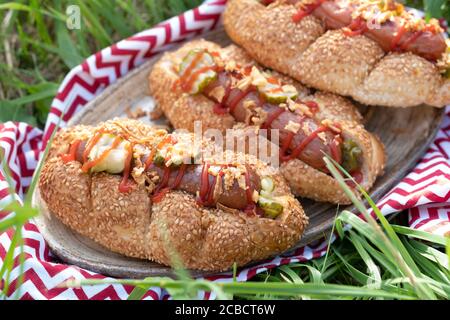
[0,0,450,299]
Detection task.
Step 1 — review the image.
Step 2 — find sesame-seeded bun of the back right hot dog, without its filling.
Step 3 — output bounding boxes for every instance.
[224,0,450,107]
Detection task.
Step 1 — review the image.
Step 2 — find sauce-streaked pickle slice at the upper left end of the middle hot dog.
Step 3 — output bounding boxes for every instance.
[179,49,217,94]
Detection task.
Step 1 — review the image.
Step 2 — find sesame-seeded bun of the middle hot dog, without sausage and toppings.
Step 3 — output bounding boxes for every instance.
[149,40,386,204]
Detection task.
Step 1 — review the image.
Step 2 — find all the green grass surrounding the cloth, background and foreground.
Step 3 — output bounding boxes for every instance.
[0,0,450,299]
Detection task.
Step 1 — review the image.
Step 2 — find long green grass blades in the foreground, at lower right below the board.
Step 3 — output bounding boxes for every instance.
[63,159,450,300]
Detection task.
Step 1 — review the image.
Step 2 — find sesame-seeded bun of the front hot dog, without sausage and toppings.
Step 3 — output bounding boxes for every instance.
[39,120,308,271]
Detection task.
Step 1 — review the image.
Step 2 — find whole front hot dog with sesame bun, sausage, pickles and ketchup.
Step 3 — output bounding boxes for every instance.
[39,119,307,271]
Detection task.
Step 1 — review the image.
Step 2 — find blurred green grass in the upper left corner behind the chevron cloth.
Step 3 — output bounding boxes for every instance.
[0,0,202,127]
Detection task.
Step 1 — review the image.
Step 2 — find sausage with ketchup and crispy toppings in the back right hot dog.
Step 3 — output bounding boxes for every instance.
[265,0,447,61]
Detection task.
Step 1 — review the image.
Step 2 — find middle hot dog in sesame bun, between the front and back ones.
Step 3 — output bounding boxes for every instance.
[149,40,385,203]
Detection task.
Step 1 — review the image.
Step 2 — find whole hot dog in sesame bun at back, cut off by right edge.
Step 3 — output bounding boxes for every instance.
[224,0,450,107]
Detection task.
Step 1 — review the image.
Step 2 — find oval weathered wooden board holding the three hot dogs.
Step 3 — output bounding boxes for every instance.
[34,30,444,278]
